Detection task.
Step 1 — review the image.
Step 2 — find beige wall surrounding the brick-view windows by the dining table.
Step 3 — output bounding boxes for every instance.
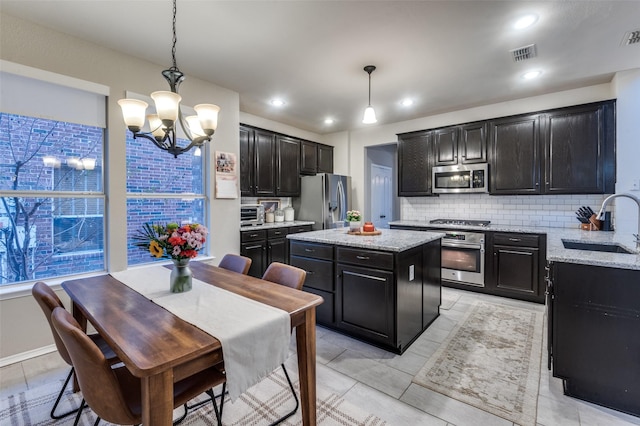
[0,14,240,364]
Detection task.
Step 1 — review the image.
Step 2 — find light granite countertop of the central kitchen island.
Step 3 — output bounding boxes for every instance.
[287,228,444,252]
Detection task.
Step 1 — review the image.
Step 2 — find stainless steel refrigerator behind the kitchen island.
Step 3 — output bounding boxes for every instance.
[293,173,351,230]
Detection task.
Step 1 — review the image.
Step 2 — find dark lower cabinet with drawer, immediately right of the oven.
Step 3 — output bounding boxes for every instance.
[487,233,546,302]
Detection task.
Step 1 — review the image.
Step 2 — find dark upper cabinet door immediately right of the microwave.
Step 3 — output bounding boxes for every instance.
[489,114,541,194]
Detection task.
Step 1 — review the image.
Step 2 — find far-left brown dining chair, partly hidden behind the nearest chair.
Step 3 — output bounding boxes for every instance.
[31,281,120,420]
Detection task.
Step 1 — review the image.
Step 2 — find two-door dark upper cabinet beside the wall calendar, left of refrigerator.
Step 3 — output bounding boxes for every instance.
[240,126,276,197]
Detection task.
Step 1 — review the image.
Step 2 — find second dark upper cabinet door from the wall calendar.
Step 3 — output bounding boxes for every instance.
[254,129,276,196]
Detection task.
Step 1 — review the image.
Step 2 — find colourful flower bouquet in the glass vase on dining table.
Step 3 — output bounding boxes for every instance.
[134,223,209,260]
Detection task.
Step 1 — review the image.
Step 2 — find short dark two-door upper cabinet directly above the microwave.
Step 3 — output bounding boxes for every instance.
[433,122,487,166]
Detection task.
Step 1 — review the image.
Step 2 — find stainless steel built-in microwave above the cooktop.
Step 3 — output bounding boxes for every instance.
[432,163,489,194]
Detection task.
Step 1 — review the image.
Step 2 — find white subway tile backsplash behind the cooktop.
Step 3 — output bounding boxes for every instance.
[400,194,609,228]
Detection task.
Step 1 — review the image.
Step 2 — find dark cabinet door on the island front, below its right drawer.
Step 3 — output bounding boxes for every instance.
[336,264,395,345]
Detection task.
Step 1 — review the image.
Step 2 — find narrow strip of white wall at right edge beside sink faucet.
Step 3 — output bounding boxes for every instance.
[613,69,640,234]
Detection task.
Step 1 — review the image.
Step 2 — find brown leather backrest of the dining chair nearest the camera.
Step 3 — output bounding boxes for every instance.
[51,308,141,424]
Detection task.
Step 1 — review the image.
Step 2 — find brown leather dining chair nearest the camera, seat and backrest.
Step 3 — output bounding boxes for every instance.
[51,308,226,426]
